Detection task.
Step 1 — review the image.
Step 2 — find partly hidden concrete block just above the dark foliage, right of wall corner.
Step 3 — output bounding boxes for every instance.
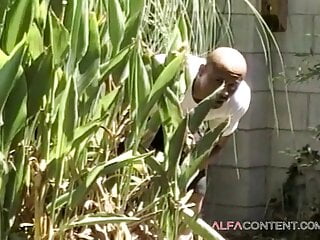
[270,130,319,168]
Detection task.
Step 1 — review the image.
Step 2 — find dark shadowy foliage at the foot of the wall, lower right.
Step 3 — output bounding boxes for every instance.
[266,127,320,239]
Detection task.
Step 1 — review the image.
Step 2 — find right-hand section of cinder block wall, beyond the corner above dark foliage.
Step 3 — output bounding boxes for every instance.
[266,0,320,210]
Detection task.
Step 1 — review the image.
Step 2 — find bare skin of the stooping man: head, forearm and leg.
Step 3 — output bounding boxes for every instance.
[181,48,247,237]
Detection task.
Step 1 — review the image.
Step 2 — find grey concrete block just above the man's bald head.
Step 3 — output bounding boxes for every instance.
[217,14,263,53]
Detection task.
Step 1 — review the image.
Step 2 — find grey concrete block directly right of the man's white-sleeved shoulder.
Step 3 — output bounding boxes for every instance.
[239,91,272,129]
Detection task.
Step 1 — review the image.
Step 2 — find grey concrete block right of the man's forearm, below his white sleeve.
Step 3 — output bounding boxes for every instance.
[214,130,271,168]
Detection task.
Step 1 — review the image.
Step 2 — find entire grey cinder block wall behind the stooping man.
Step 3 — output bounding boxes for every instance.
[203,0,320,223]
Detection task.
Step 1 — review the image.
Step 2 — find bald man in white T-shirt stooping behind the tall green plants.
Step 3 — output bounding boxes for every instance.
[156,47,251,240]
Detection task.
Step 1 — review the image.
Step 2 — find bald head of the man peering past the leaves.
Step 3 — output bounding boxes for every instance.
[193,47,247,100]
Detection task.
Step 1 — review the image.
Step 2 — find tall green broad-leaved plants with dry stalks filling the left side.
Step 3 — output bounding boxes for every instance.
[0,0,280,239]
